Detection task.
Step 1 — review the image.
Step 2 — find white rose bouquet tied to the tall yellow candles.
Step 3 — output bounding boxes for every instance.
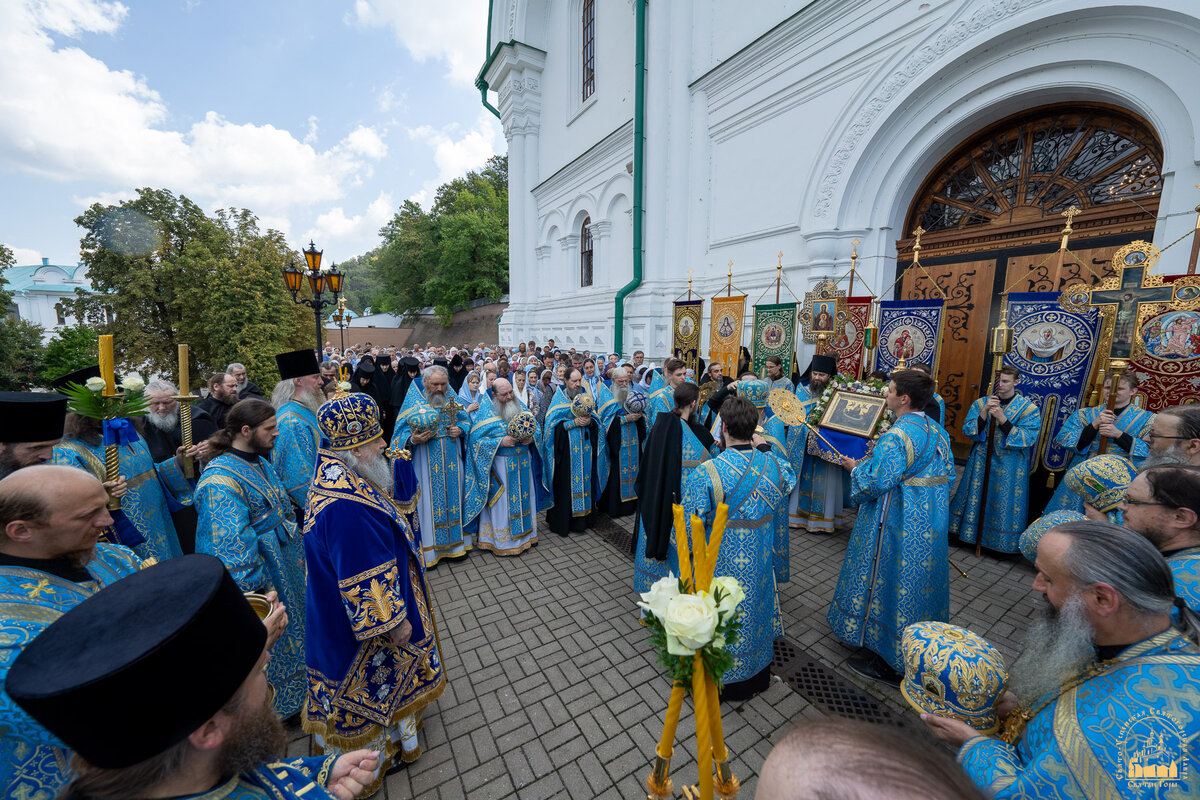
[637,575,745,687]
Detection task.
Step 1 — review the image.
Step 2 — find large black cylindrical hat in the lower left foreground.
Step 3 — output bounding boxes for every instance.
[5,554,266,769]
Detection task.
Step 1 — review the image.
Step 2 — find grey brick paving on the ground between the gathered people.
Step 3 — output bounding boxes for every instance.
[285,496,1037,800]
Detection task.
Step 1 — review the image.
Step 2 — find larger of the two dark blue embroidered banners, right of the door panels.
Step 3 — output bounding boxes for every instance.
[1004,291,1100,471]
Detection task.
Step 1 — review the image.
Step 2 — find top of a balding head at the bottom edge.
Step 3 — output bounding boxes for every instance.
[754,717,984,800]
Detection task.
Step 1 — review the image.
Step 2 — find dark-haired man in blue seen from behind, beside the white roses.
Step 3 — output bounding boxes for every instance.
[677,397,796,702]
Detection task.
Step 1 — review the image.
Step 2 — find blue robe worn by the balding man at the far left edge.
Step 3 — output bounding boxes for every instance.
[0,543,142,800]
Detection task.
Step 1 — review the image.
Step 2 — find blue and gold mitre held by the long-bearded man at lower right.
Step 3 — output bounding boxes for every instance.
[900,621,1008,733]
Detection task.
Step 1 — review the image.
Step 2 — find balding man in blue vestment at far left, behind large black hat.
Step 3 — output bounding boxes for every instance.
[0,462,142,800]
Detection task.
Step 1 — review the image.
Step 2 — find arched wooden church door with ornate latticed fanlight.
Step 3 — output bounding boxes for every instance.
[895,106,1163,458]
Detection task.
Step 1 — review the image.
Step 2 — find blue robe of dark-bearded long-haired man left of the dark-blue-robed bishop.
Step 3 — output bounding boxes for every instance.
[196,452,305,718]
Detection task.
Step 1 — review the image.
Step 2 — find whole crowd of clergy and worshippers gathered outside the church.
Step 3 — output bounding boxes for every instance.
[0,341,1200,800]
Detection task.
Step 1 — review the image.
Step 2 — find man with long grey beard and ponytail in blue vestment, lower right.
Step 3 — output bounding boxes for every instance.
[922,519,1200,800]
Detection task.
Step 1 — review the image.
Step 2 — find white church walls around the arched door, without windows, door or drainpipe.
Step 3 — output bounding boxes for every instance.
[481,0,1200,362]
